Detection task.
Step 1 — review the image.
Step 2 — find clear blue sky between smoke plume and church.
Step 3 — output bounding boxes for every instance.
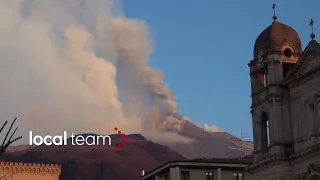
[122,0,320,140]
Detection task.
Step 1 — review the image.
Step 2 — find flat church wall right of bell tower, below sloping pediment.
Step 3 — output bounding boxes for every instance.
[290,68,320,153]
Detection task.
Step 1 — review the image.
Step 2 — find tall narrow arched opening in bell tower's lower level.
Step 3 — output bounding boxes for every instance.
[261,111,270,151]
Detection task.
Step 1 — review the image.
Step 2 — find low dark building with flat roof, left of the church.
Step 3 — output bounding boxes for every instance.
[141,159,252,180]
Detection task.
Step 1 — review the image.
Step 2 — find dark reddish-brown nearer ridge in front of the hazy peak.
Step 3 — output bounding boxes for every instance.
[2,135,184,180]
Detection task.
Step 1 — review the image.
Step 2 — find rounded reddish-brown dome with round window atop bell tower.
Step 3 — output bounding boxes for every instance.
[254,21,302,59]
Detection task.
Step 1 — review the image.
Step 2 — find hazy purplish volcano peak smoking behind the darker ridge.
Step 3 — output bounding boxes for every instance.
[151,119,253,159]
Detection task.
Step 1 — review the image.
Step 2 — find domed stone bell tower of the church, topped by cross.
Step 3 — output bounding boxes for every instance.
[248,4,302,162]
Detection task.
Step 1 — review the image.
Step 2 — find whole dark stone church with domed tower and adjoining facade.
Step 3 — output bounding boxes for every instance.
[247,16,320,180]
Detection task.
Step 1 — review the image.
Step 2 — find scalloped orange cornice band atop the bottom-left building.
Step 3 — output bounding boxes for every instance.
[0,161,61,176]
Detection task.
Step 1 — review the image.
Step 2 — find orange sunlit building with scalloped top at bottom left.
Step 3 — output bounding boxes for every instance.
[0,162,61,180]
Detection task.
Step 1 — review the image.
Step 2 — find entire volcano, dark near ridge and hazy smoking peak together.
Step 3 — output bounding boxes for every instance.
[2,118,252,180]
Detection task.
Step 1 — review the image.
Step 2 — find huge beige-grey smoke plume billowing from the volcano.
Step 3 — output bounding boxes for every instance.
[0,0,177,142]
